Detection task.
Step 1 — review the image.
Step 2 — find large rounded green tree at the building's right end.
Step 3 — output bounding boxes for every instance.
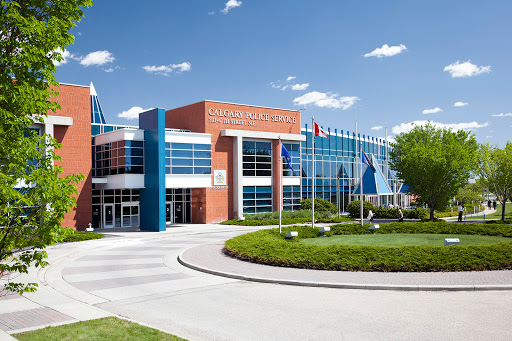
[389,123,478,220]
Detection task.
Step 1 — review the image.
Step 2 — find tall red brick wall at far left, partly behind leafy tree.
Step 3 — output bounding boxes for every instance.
[48,85,92,230]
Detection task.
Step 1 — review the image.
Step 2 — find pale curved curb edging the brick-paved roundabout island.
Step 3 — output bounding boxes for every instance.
[178,247,512,291]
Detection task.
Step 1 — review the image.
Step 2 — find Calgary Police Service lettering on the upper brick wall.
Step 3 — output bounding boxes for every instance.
[208,108,297,127]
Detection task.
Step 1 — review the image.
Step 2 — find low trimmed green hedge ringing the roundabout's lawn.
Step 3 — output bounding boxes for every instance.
[224,222,512,271]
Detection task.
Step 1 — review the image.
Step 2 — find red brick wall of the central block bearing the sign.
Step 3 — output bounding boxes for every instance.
[165,101,300,223]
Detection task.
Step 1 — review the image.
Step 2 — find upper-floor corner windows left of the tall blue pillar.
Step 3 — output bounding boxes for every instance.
[92,140,144,177]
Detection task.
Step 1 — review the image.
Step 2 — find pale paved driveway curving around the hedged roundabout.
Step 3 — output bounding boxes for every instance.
[4,225,512,340]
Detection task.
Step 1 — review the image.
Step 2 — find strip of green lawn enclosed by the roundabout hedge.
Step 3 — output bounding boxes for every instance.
[301,233,510,246]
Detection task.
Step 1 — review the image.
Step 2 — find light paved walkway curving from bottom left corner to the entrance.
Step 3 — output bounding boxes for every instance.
[0,224,254,340]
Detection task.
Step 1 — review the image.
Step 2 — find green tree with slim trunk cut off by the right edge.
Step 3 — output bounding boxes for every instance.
[477,142,512,220]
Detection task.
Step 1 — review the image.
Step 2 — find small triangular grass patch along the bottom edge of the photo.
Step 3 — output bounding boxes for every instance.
[13,317,185,341]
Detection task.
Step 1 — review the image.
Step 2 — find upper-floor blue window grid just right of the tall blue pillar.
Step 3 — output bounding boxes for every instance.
[165,142,212,174]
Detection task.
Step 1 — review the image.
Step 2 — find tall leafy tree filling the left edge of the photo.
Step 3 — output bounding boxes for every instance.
[0,0,92,294]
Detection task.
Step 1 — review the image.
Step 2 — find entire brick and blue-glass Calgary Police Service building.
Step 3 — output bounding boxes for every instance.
[51,83,407,231]
